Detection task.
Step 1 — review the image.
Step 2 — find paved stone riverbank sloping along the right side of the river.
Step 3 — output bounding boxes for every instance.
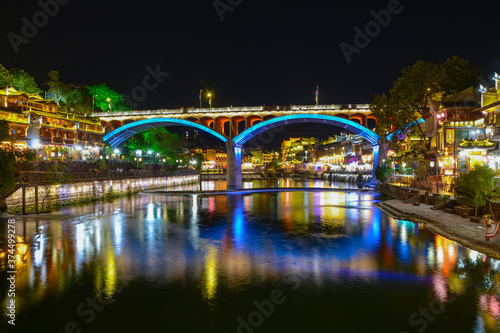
[375,199,500,260]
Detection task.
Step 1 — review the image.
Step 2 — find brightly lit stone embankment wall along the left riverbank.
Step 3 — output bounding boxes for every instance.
[7,175,199,210]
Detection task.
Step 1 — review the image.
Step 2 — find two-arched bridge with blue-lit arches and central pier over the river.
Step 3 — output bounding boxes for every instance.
[99,104,380,189]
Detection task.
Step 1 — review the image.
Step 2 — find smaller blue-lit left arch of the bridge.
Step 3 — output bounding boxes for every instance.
[104,118,227,147]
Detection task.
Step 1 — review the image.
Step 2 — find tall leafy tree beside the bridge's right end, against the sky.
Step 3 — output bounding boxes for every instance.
[371,56,481,148]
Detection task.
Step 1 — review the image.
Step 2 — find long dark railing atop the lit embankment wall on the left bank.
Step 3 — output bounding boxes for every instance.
[16,170,199,186]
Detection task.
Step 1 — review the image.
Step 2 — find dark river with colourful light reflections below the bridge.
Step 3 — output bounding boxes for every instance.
[0,180,500,333]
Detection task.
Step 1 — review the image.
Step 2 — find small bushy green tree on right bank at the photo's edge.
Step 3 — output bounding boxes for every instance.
[455,166,500,219]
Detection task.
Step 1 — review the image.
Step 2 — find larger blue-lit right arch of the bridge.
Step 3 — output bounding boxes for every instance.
[233,114,380,148]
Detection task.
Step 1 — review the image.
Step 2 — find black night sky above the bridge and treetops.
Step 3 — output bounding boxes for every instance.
[0,0,500,145]
